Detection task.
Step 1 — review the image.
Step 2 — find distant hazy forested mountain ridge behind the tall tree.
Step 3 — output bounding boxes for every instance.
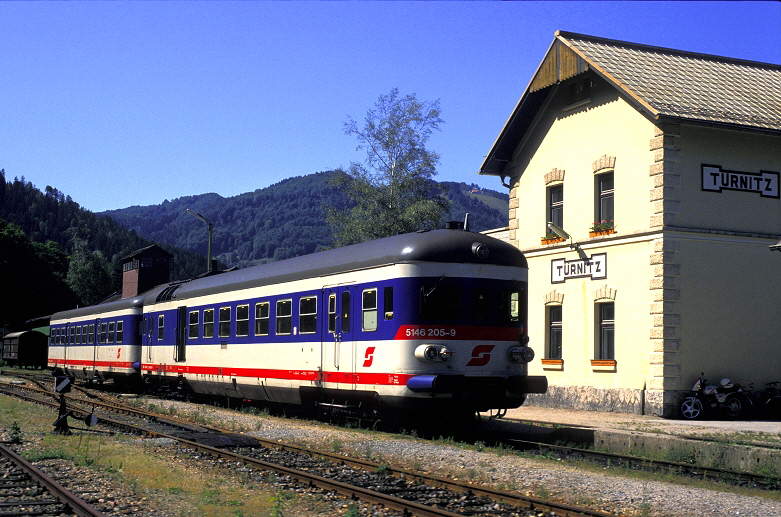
[103,171,509,267]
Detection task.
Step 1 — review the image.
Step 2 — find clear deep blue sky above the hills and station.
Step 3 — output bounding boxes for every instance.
[0,1,781,212]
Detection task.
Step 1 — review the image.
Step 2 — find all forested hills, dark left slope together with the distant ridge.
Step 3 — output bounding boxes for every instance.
[0,170,509,333]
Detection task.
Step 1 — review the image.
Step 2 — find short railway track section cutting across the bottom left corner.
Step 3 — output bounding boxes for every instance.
[0,444,103,517]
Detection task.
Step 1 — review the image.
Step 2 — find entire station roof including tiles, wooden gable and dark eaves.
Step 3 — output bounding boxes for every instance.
[480,31,781,176]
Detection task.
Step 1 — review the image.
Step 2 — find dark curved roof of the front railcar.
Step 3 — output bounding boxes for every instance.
[144,230,527,304]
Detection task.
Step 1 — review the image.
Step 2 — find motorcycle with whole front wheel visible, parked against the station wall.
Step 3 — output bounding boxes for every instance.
[681,374,751,419]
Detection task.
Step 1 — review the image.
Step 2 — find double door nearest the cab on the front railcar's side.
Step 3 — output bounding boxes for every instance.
[321,286,355,389]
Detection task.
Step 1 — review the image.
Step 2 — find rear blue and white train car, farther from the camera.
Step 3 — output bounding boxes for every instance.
[48,296,144,383]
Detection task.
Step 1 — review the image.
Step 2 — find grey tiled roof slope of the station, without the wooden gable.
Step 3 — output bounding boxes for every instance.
[557,32,781,130]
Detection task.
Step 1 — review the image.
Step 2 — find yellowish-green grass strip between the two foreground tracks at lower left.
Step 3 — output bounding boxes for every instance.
[0,396,330,517]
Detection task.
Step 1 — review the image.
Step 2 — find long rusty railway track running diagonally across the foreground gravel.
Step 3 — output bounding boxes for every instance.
[0,376,612,517]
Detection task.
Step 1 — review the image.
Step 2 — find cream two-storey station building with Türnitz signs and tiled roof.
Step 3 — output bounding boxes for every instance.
[480,32,781,417]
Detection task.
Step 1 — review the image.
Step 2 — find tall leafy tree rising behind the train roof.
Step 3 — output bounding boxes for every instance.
[327,88,449,246]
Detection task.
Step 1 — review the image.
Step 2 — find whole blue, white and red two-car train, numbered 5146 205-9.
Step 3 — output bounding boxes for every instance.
[48,229,547,419]
